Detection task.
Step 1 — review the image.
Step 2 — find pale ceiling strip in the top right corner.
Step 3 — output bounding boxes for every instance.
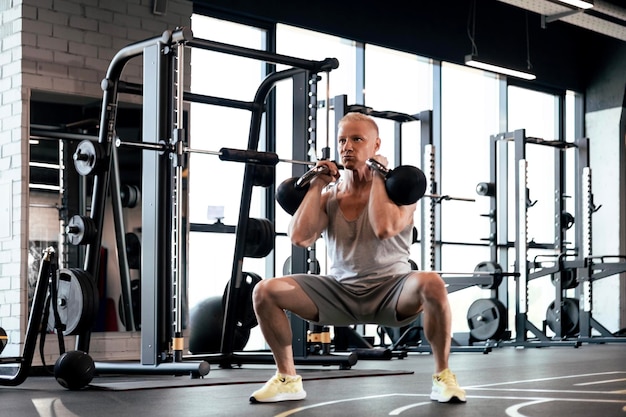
[498,0,626,41]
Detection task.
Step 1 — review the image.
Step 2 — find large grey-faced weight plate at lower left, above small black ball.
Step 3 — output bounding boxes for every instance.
[48,269,98,336]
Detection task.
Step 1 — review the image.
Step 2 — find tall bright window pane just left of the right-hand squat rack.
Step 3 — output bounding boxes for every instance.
[439,63,499,250]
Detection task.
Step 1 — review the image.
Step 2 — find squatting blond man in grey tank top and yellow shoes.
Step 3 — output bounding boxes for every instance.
[250,113,465,403]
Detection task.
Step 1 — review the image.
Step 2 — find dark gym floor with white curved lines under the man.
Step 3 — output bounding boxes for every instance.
[0,343,626,417]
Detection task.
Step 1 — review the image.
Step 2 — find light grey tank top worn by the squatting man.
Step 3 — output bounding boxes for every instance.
[323,185,413,290]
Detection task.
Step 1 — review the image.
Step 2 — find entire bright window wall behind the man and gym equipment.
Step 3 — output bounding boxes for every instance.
[189,15,580,342]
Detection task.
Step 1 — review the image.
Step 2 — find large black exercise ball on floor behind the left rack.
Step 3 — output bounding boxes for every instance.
[189,296,250,355]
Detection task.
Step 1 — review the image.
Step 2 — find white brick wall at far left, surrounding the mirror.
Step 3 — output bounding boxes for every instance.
[0,0,192,361]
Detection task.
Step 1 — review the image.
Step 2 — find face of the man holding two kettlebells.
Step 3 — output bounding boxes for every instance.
[337,121,380,169]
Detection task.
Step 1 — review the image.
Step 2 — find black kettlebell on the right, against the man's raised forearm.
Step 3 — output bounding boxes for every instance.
[365,158,426,206]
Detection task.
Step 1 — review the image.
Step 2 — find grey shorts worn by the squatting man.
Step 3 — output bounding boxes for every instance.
[292,273,417,327]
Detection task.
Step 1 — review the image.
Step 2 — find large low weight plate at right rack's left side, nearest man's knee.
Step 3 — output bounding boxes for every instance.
[467,298,506,340]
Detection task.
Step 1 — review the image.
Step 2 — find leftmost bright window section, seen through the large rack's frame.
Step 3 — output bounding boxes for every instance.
[188,15,266,316]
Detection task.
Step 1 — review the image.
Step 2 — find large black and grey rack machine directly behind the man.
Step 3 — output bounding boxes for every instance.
[76,28,356,376]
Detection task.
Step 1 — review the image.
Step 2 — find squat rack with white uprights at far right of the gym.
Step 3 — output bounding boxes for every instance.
[484,129,626,347]
